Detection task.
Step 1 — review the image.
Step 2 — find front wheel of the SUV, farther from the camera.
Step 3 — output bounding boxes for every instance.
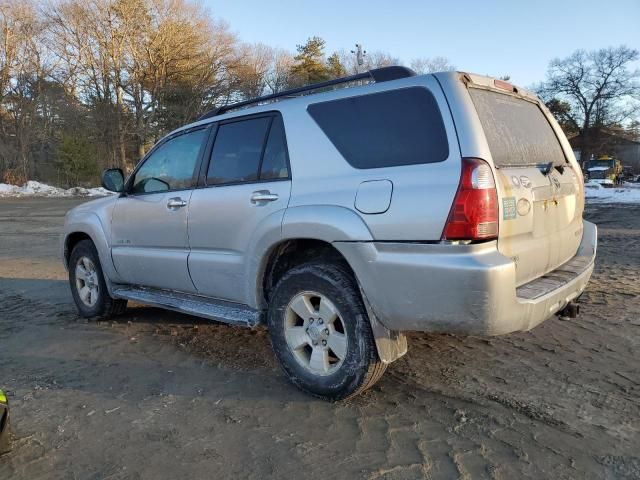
[69,240,127,320]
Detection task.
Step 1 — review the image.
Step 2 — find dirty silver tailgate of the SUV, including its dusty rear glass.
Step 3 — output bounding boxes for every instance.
[469,87,584,285]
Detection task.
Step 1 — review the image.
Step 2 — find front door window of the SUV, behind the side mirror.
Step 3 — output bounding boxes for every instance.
[133,129,208,193]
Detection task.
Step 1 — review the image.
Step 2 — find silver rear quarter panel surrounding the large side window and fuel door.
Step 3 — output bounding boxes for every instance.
[281,75,460,241]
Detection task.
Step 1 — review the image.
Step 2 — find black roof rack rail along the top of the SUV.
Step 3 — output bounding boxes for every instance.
[198,66,416,120]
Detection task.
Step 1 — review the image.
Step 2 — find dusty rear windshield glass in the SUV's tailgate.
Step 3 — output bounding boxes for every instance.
[469,88,566,167]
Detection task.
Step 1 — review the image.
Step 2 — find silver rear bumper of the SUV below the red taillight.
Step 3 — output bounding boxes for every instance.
[335,221,597,335]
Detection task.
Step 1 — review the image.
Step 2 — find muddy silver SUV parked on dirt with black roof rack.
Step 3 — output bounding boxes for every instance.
[62,67,596,400]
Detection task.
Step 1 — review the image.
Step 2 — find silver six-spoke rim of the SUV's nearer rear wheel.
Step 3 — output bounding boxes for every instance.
[284,292,348,375]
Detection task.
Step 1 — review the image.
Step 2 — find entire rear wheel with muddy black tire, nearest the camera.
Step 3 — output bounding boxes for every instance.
[267,263,386,400]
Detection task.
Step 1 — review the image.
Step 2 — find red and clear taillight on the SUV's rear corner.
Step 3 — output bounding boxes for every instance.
[442,158,498,240]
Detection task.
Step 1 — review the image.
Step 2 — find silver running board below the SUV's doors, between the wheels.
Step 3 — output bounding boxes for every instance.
[113,285,262,327]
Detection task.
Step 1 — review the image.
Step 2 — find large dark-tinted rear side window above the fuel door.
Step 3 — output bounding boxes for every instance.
[308,87,449,168]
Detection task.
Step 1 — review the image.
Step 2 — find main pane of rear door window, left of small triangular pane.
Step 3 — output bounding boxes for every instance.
[207,117,271,185]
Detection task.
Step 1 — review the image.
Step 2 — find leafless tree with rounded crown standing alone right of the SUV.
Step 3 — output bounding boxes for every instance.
[539,46,640,159]
